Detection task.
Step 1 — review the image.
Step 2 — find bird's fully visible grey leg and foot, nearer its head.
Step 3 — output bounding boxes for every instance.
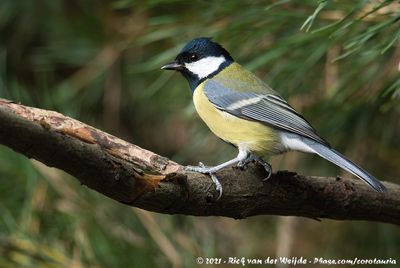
[185,149,249,200]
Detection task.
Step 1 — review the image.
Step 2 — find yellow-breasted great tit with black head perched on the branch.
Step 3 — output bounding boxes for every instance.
[161,37,386,200]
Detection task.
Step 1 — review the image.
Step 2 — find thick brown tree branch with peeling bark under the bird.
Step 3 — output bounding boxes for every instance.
[0,99,400,224]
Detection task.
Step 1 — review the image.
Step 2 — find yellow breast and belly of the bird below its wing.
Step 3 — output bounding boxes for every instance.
[193,83,279,156]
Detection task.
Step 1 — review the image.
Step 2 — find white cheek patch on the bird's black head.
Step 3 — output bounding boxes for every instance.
[185,56,226,79]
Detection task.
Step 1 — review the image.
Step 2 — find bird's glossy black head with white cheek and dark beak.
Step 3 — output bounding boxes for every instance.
[161,37,233,90]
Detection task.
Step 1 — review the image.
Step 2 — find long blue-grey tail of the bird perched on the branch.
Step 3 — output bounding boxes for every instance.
[303,139,386,192]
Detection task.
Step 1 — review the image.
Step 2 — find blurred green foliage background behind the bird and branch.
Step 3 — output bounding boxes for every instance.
[0,0,400,267]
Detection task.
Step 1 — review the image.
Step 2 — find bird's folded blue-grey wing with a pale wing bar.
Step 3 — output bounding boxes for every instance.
[203,79,329,146]
